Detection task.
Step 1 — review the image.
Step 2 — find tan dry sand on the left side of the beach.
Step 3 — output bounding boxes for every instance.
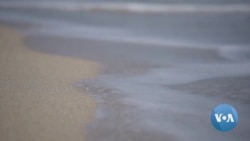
[0,27,98,141]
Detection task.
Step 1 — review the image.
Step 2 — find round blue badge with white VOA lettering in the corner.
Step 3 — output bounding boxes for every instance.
[211,104,238,132]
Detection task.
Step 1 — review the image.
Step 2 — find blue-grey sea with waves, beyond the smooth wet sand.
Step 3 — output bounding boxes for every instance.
[0,0,250,48]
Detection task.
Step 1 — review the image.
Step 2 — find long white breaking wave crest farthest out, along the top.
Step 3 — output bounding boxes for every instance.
[0,2,250,13]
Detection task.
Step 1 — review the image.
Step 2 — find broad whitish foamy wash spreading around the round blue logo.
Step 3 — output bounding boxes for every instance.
[81,63,250,141]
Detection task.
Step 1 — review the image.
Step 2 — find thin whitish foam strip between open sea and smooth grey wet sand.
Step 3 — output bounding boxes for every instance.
[26,24,250,61]
